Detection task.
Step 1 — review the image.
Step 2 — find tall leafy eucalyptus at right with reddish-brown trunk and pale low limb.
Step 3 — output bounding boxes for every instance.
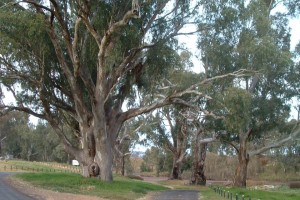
[199,0,299,187]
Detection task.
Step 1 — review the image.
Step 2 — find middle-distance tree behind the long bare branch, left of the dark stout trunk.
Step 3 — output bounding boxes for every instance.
[139,69,205,179]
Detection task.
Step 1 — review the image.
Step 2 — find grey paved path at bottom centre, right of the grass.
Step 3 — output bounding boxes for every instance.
[153,190,199,200]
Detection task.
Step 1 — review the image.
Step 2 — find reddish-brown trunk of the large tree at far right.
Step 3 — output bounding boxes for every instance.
[233,141,249,187]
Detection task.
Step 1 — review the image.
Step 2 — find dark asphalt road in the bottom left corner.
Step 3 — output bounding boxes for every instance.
[0,172,33,200]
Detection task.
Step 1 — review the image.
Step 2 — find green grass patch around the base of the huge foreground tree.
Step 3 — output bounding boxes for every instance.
[16,173,167,200]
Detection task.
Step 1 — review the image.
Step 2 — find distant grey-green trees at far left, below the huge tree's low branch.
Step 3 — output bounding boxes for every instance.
[0,112,68,162]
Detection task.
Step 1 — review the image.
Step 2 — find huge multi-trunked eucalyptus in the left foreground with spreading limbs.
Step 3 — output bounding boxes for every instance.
[0,0,206,181]
